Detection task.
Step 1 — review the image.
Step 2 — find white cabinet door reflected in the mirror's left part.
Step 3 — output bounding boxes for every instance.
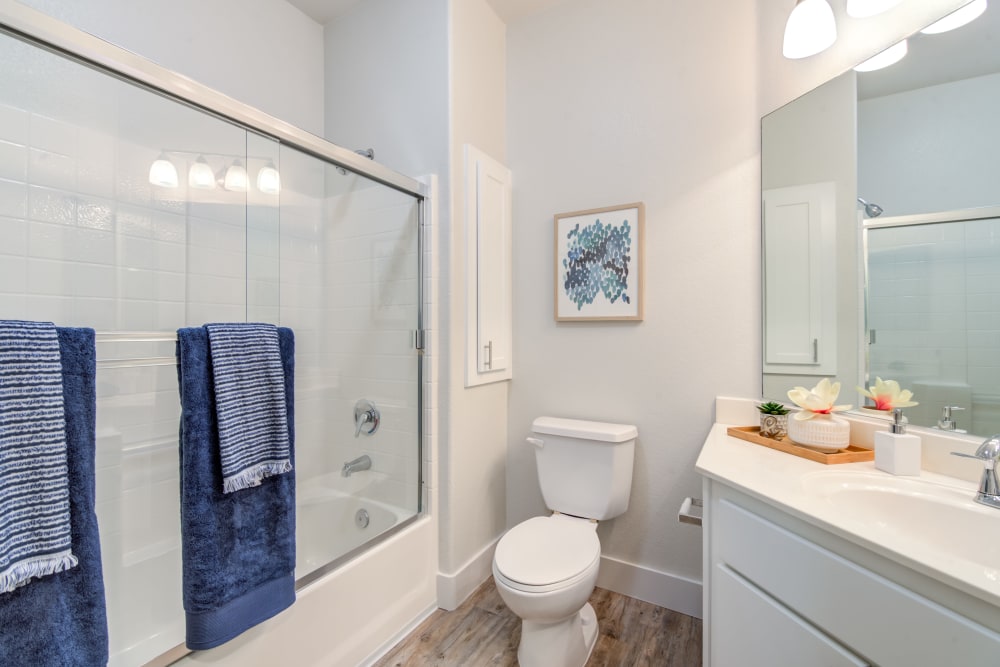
[763,183,837,375]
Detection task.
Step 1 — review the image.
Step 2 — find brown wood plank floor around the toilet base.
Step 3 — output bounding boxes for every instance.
[374,578,701,667]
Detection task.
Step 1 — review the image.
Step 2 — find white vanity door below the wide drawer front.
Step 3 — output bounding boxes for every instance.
[711,564,869,667]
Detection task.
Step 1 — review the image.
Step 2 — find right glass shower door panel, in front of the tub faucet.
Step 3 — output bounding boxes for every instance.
[281,147,420,578]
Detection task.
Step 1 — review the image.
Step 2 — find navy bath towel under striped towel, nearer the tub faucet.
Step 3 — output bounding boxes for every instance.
[177,327,295,650]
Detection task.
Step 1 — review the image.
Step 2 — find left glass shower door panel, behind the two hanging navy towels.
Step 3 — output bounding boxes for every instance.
[0,28,254,666]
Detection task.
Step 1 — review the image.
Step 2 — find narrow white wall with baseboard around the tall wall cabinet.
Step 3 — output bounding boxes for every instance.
[438,0,508,608]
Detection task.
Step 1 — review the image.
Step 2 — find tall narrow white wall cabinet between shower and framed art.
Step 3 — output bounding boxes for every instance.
[465,144,513,387]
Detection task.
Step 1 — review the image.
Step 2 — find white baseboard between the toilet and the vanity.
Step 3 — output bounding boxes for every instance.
[597,556,702,618]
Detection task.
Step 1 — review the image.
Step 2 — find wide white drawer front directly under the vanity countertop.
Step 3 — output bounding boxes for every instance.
[710,499,1000,667]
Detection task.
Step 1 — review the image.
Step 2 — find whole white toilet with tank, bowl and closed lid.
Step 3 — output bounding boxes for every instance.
[493,417,638,667]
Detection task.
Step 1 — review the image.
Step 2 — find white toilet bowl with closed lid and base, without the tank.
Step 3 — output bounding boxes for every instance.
[493,514,601,667]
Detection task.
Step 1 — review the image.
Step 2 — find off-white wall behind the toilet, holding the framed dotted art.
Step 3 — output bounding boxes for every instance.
[507,0,760,611]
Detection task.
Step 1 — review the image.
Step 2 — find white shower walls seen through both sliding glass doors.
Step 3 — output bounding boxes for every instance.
[0,26,422,666]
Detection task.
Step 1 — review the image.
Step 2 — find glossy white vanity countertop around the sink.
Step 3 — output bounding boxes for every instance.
[695,424,1000,606]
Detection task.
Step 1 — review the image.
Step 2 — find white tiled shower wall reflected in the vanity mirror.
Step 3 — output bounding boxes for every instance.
[868,218,1000,434]
